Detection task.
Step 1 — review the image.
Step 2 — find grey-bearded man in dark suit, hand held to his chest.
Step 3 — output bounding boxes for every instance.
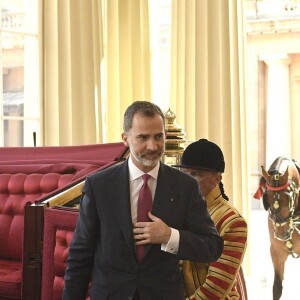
[63,101,223,300]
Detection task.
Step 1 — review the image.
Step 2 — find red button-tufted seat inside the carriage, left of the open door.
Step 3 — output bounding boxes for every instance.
[0,163,98,300]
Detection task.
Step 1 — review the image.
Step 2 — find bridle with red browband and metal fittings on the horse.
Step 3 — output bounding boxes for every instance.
[265,174,300,257]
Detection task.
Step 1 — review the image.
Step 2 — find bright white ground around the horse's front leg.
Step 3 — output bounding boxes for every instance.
[245,210,300,300]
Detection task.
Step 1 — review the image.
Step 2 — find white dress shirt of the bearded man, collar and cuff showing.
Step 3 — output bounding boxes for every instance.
[128,157,180,254]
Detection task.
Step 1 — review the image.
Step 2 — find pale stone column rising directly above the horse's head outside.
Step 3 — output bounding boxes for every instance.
[260,54,292,168]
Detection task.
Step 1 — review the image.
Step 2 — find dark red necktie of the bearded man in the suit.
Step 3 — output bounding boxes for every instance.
[136,174,152,262]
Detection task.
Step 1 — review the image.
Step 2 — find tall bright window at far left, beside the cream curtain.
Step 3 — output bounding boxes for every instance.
[0,0,40,146]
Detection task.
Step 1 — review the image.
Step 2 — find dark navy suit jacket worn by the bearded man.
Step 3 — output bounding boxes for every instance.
[63,161,223,300]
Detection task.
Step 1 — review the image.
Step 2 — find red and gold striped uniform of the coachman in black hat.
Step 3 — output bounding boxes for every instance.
[182,186,247,300]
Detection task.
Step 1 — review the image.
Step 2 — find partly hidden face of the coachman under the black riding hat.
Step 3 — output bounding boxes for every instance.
[183,168,222,197]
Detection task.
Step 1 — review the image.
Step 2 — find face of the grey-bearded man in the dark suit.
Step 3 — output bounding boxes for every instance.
[122,113,166,172]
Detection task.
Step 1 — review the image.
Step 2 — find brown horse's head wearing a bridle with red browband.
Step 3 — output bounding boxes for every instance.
[261,157,300,241]
